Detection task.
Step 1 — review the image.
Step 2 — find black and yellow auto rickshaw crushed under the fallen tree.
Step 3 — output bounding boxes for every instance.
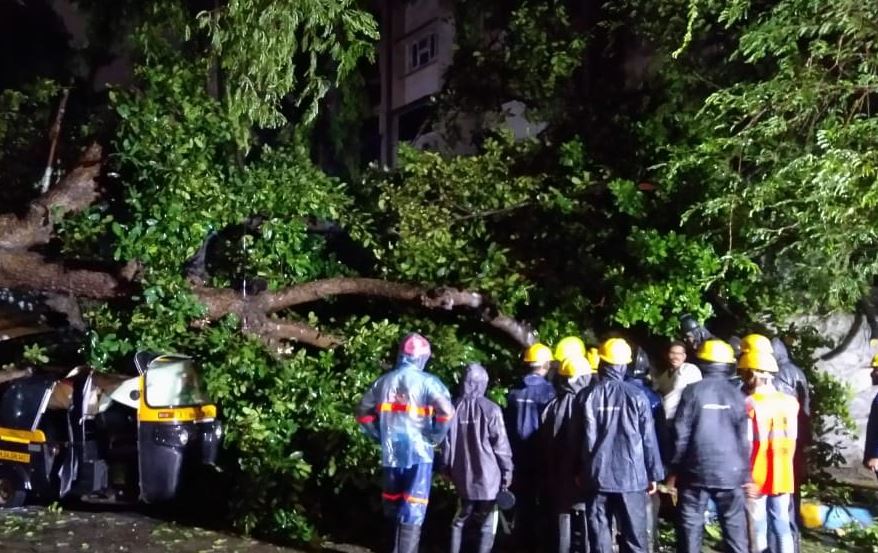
[0,352,222,508]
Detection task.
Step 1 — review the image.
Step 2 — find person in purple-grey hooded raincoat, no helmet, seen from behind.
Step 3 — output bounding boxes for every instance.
[441,363,512,553]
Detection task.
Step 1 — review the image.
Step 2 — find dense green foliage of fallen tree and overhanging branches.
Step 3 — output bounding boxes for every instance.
[0,0,878,541]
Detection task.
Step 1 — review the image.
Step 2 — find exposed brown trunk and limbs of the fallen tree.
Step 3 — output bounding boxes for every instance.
[0,144,535,348]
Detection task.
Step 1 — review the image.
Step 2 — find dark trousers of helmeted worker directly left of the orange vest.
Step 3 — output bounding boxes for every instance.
[677,486,749,553]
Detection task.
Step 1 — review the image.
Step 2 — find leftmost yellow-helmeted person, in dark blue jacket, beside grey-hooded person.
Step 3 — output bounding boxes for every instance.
[505,344,555,551]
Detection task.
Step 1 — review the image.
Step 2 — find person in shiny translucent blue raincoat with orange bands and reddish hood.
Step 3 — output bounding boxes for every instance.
[356,333,454,553]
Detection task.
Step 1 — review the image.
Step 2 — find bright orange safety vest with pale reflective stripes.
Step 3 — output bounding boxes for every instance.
[747,388,799,495]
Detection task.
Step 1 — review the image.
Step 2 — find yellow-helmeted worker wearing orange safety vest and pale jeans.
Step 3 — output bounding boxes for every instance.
[738,350,799,553]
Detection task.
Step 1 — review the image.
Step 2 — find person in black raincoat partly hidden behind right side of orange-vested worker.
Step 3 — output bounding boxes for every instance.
[770,337,811,553]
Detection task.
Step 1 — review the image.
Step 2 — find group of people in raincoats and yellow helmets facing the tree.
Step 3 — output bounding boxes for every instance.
[356,316,810,553]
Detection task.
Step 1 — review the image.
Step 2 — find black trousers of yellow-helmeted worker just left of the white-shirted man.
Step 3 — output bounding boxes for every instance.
[586,491,648,553]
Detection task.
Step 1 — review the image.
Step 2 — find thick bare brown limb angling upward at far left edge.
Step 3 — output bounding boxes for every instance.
[0,143,101,249]
